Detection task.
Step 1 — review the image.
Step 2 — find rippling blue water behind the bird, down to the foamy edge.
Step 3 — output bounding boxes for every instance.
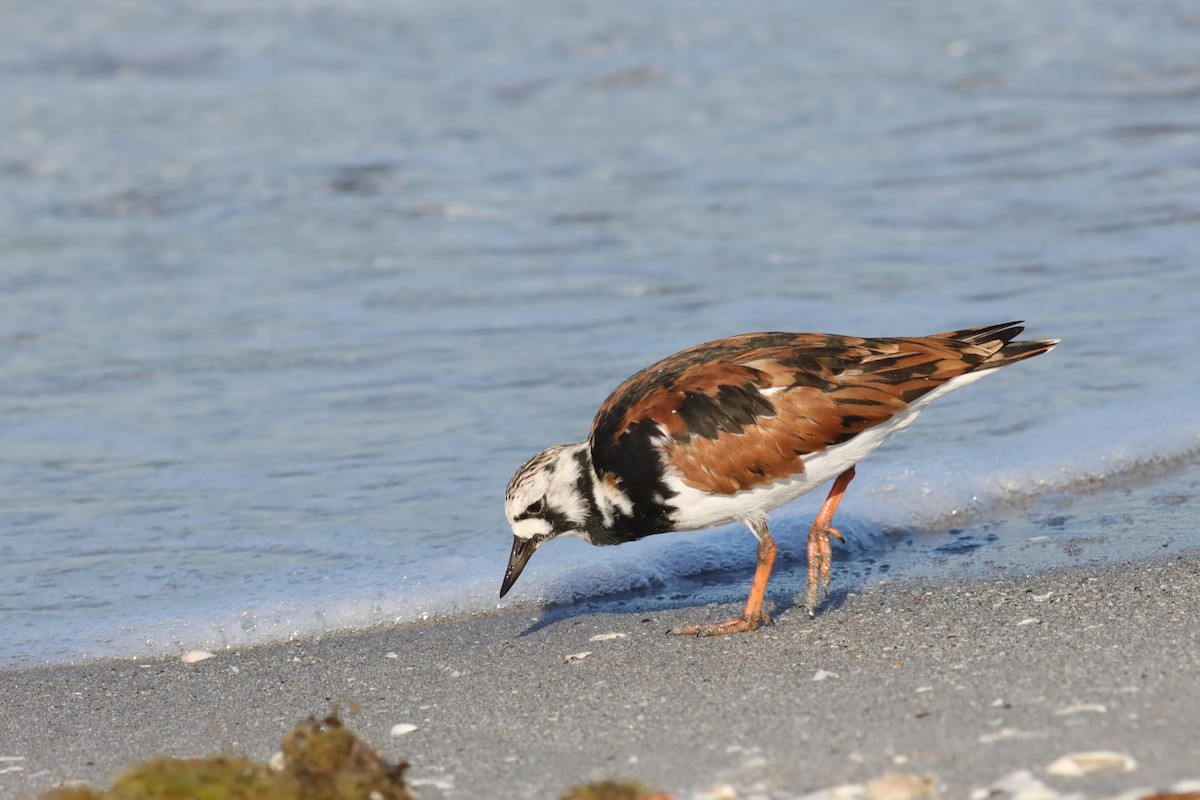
[0,0,1200,666]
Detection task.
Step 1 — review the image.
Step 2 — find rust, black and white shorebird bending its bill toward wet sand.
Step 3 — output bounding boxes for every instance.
[500,320,1058,636]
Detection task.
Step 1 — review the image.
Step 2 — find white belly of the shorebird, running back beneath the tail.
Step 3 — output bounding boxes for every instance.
[666,369,991,530]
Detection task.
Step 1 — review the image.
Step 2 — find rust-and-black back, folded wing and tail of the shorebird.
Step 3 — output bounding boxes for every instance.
[589,324,1054,496]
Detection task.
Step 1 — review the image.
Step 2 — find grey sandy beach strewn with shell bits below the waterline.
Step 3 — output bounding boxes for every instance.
[0,551,1200,798]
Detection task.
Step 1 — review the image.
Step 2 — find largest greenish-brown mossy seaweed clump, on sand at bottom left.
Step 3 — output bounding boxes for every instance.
[42,714,413,800]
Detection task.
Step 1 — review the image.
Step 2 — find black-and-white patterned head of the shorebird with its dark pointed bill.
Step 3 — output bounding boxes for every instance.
[500,441,595,597]
